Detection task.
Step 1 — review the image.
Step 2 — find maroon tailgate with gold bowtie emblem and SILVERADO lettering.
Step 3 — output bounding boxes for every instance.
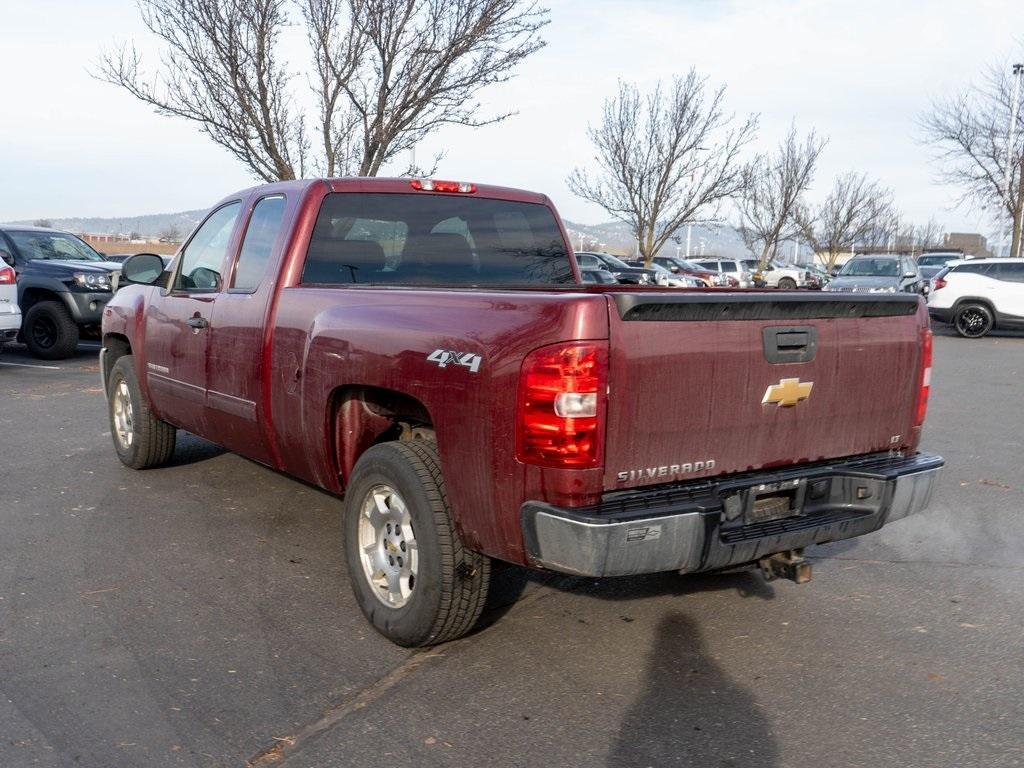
[604,292,927,490]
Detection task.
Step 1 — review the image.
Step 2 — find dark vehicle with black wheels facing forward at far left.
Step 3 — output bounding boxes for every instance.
[0,225,120,360]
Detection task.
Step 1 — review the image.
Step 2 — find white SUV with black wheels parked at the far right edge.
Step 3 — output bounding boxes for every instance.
[928,259,1024,339]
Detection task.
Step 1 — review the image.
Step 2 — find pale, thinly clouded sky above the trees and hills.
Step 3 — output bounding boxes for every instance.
[0,0,1024,232]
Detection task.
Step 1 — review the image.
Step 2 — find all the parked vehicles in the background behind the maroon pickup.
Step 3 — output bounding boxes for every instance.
[0,219,1024,359]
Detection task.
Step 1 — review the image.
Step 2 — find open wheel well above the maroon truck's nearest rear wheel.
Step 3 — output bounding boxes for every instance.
[328,386,434,485]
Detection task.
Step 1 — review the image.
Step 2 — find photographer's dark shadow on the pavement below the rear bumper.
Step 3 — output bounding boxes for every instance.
[608,612,779,768]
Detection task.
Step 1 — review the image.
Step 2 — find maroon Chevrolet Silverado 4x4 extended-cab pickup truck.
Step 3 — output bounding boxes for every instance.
[100,178,942,646]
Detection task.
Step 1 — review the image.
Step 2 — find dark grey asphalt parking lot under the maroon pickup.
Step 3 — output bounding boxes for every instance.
[0,330,1024,768]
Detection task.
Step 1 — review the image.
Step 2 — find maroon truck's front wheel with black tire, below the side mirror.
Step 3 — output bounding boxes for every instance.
[106,354,177,469]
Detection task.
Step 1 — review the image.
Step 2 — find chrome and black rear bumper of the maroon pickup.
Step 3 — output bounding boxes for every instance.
[521,454,944,577]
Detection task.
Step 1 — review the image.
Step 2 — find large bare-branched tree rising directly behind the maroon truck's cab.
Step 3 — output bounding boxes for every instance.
[97,0,548,181]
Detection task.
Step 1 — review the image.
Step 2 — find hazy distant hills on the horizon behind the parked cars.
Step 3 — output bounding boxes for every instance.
[7,209,750,256]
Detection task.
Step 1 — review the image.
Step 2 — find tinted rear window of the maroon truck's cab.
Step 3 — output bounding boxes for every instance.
[302,193,573,286]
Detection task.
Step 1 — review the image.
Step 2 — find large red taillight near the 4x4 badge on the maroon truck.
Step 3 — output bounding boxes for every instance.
[516,342,608,469]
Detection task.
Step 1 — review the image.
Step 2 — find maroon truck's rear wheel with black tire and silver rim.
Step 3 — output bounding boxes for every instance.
[343,440,490,647]
